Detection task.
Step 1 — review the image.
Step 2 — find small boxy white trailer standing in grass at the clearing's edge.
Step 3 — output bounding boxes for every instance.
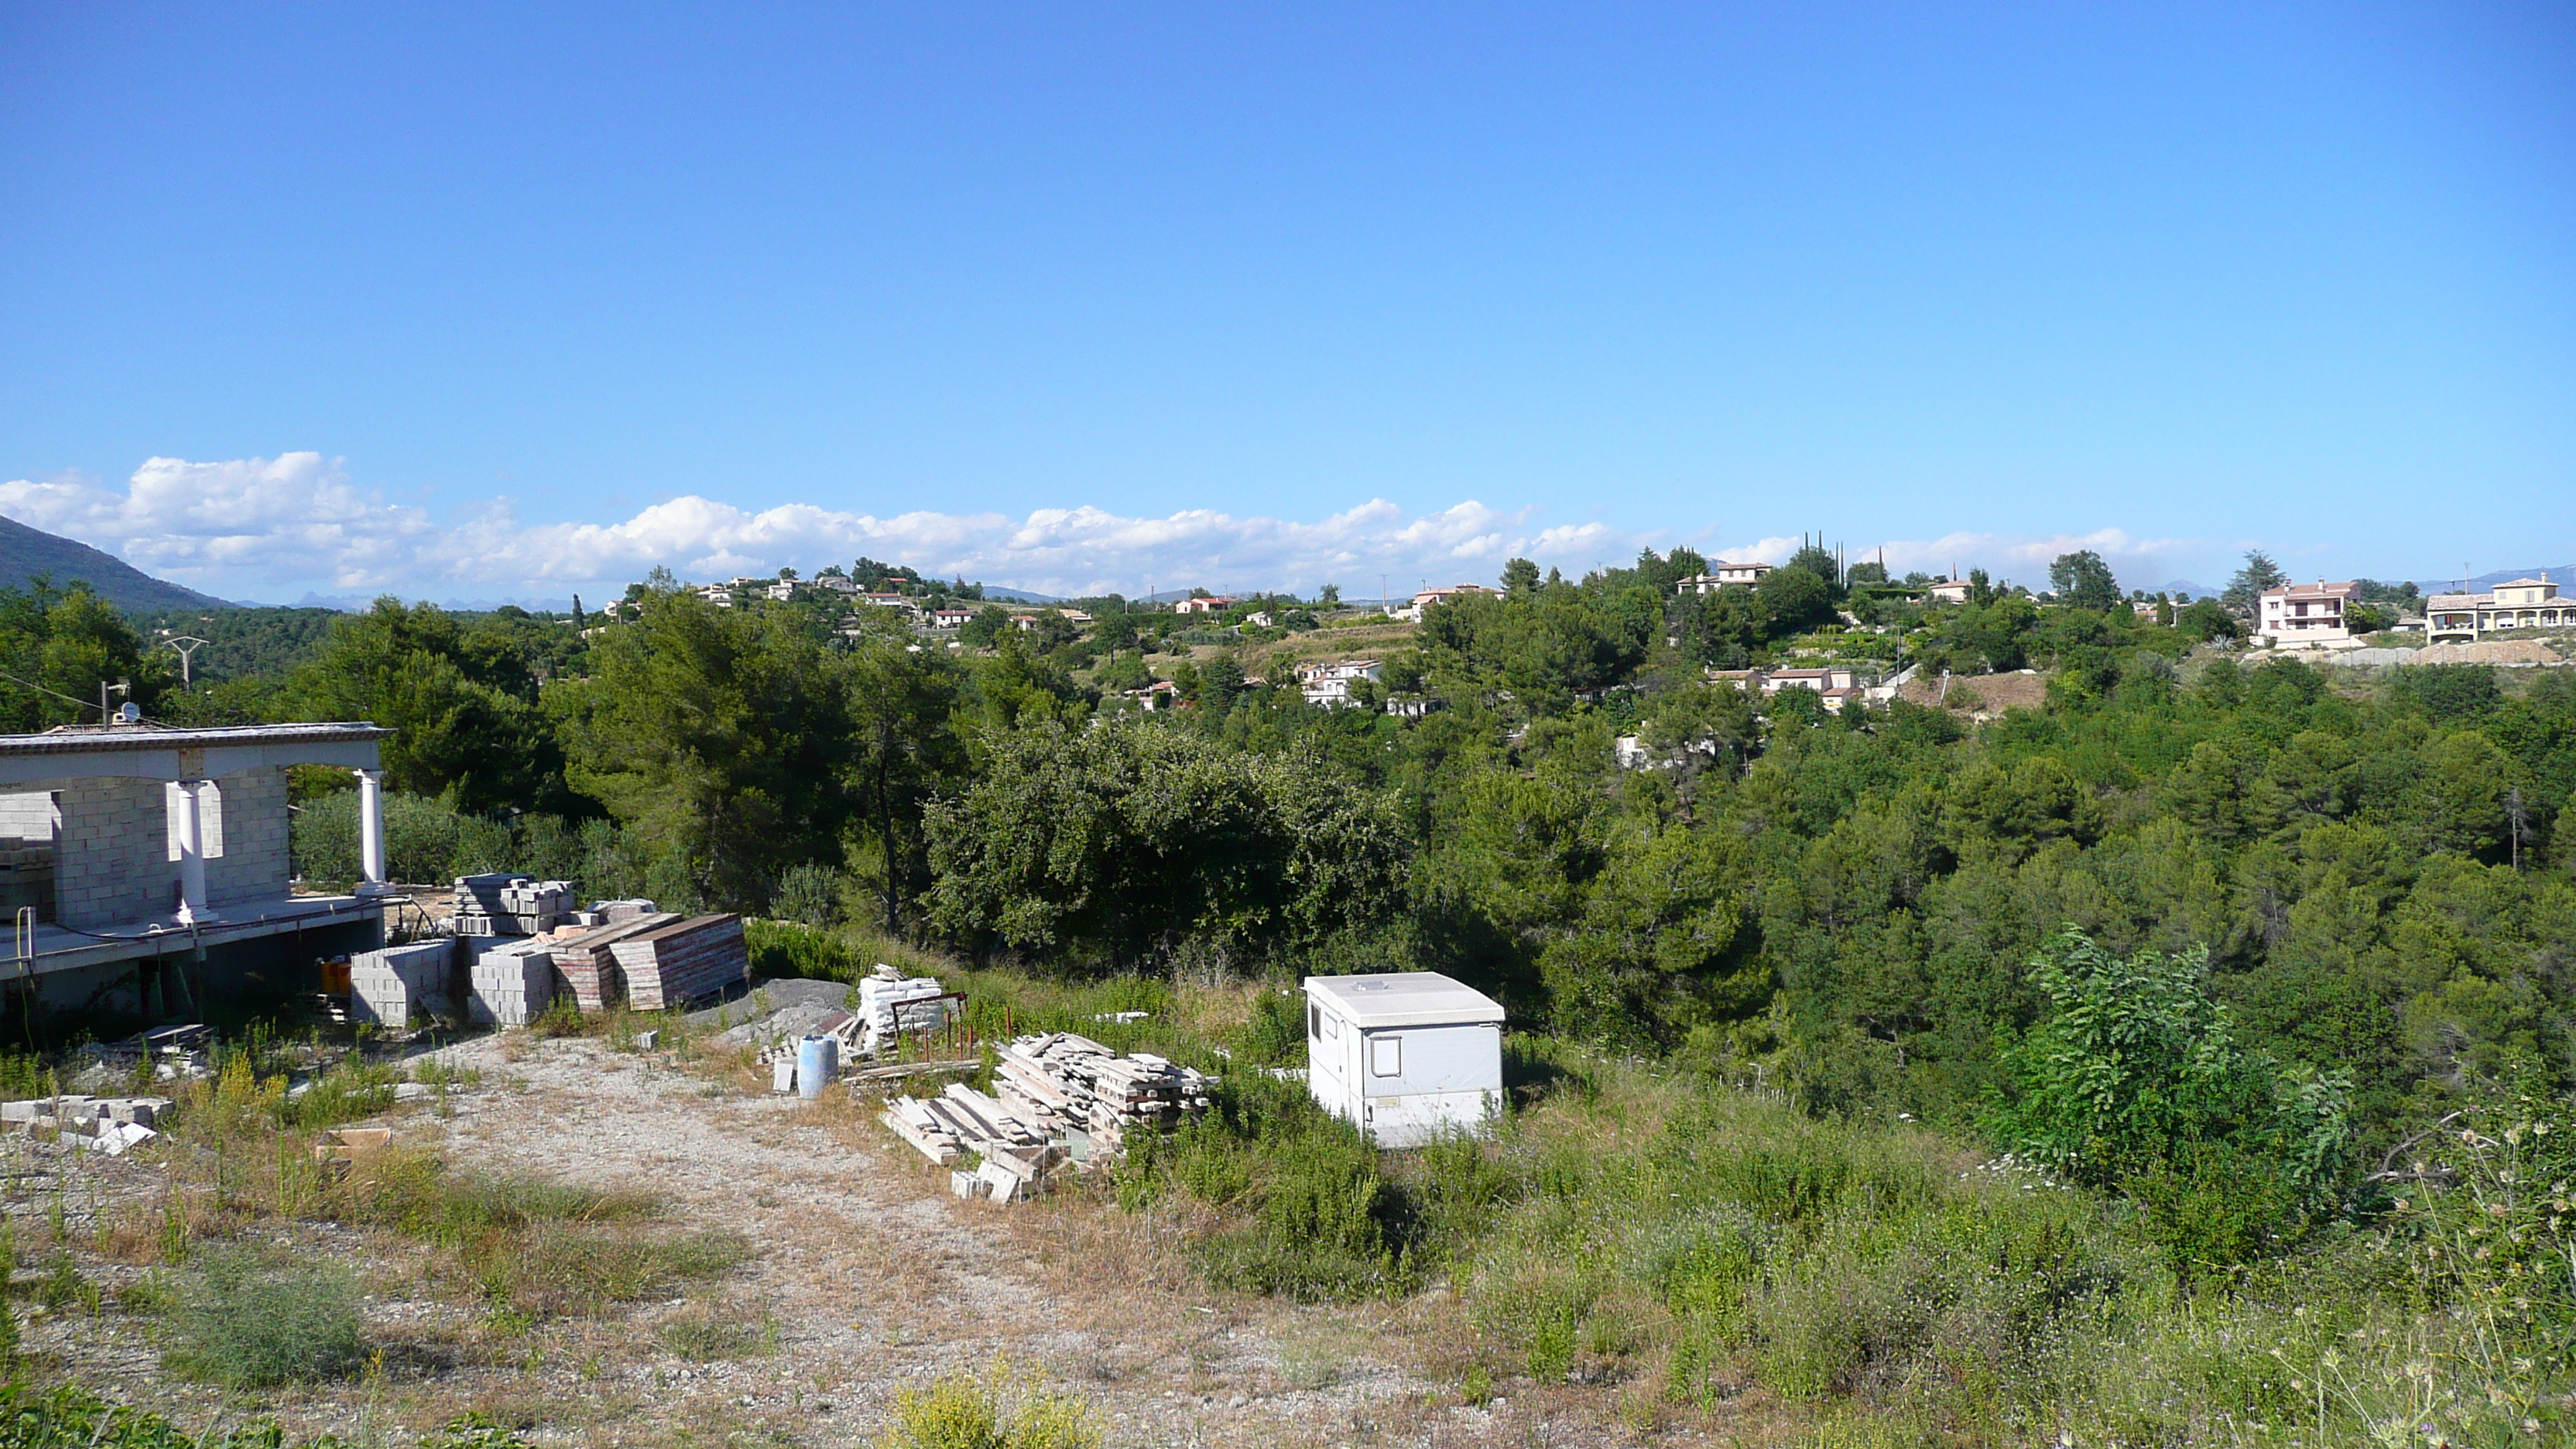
[1306,972,1502,1147]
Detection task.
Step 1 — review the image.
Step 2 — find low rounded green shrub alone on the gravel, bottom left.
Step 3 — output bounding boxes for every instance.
[165,1248,366,1387]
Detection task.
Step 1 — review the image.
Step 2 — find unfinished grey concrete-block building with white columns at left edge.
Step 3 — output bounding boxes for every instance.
[0,724,392,1026]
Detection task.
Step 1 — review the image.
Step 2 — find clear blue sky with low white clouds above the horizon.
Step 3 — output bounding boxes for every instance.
[0,5,2576,601]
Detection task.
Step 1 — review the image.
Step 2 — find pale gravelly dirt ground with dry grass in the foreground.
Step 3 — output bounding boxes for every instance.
[10,1031,1711,1449]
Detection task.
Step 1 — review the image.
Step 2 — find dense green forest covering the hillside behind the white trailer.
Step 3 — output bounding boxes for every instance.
[0,554,2576,1434]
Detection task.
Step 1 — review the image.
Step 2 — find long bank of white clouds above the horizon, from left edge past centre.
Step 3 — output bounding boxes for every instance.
[0,454,1646,598]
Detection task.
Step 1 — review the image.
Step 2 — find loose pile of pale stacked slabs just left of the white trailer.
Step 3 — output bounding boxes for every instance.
[879,1031,1216,1201]
